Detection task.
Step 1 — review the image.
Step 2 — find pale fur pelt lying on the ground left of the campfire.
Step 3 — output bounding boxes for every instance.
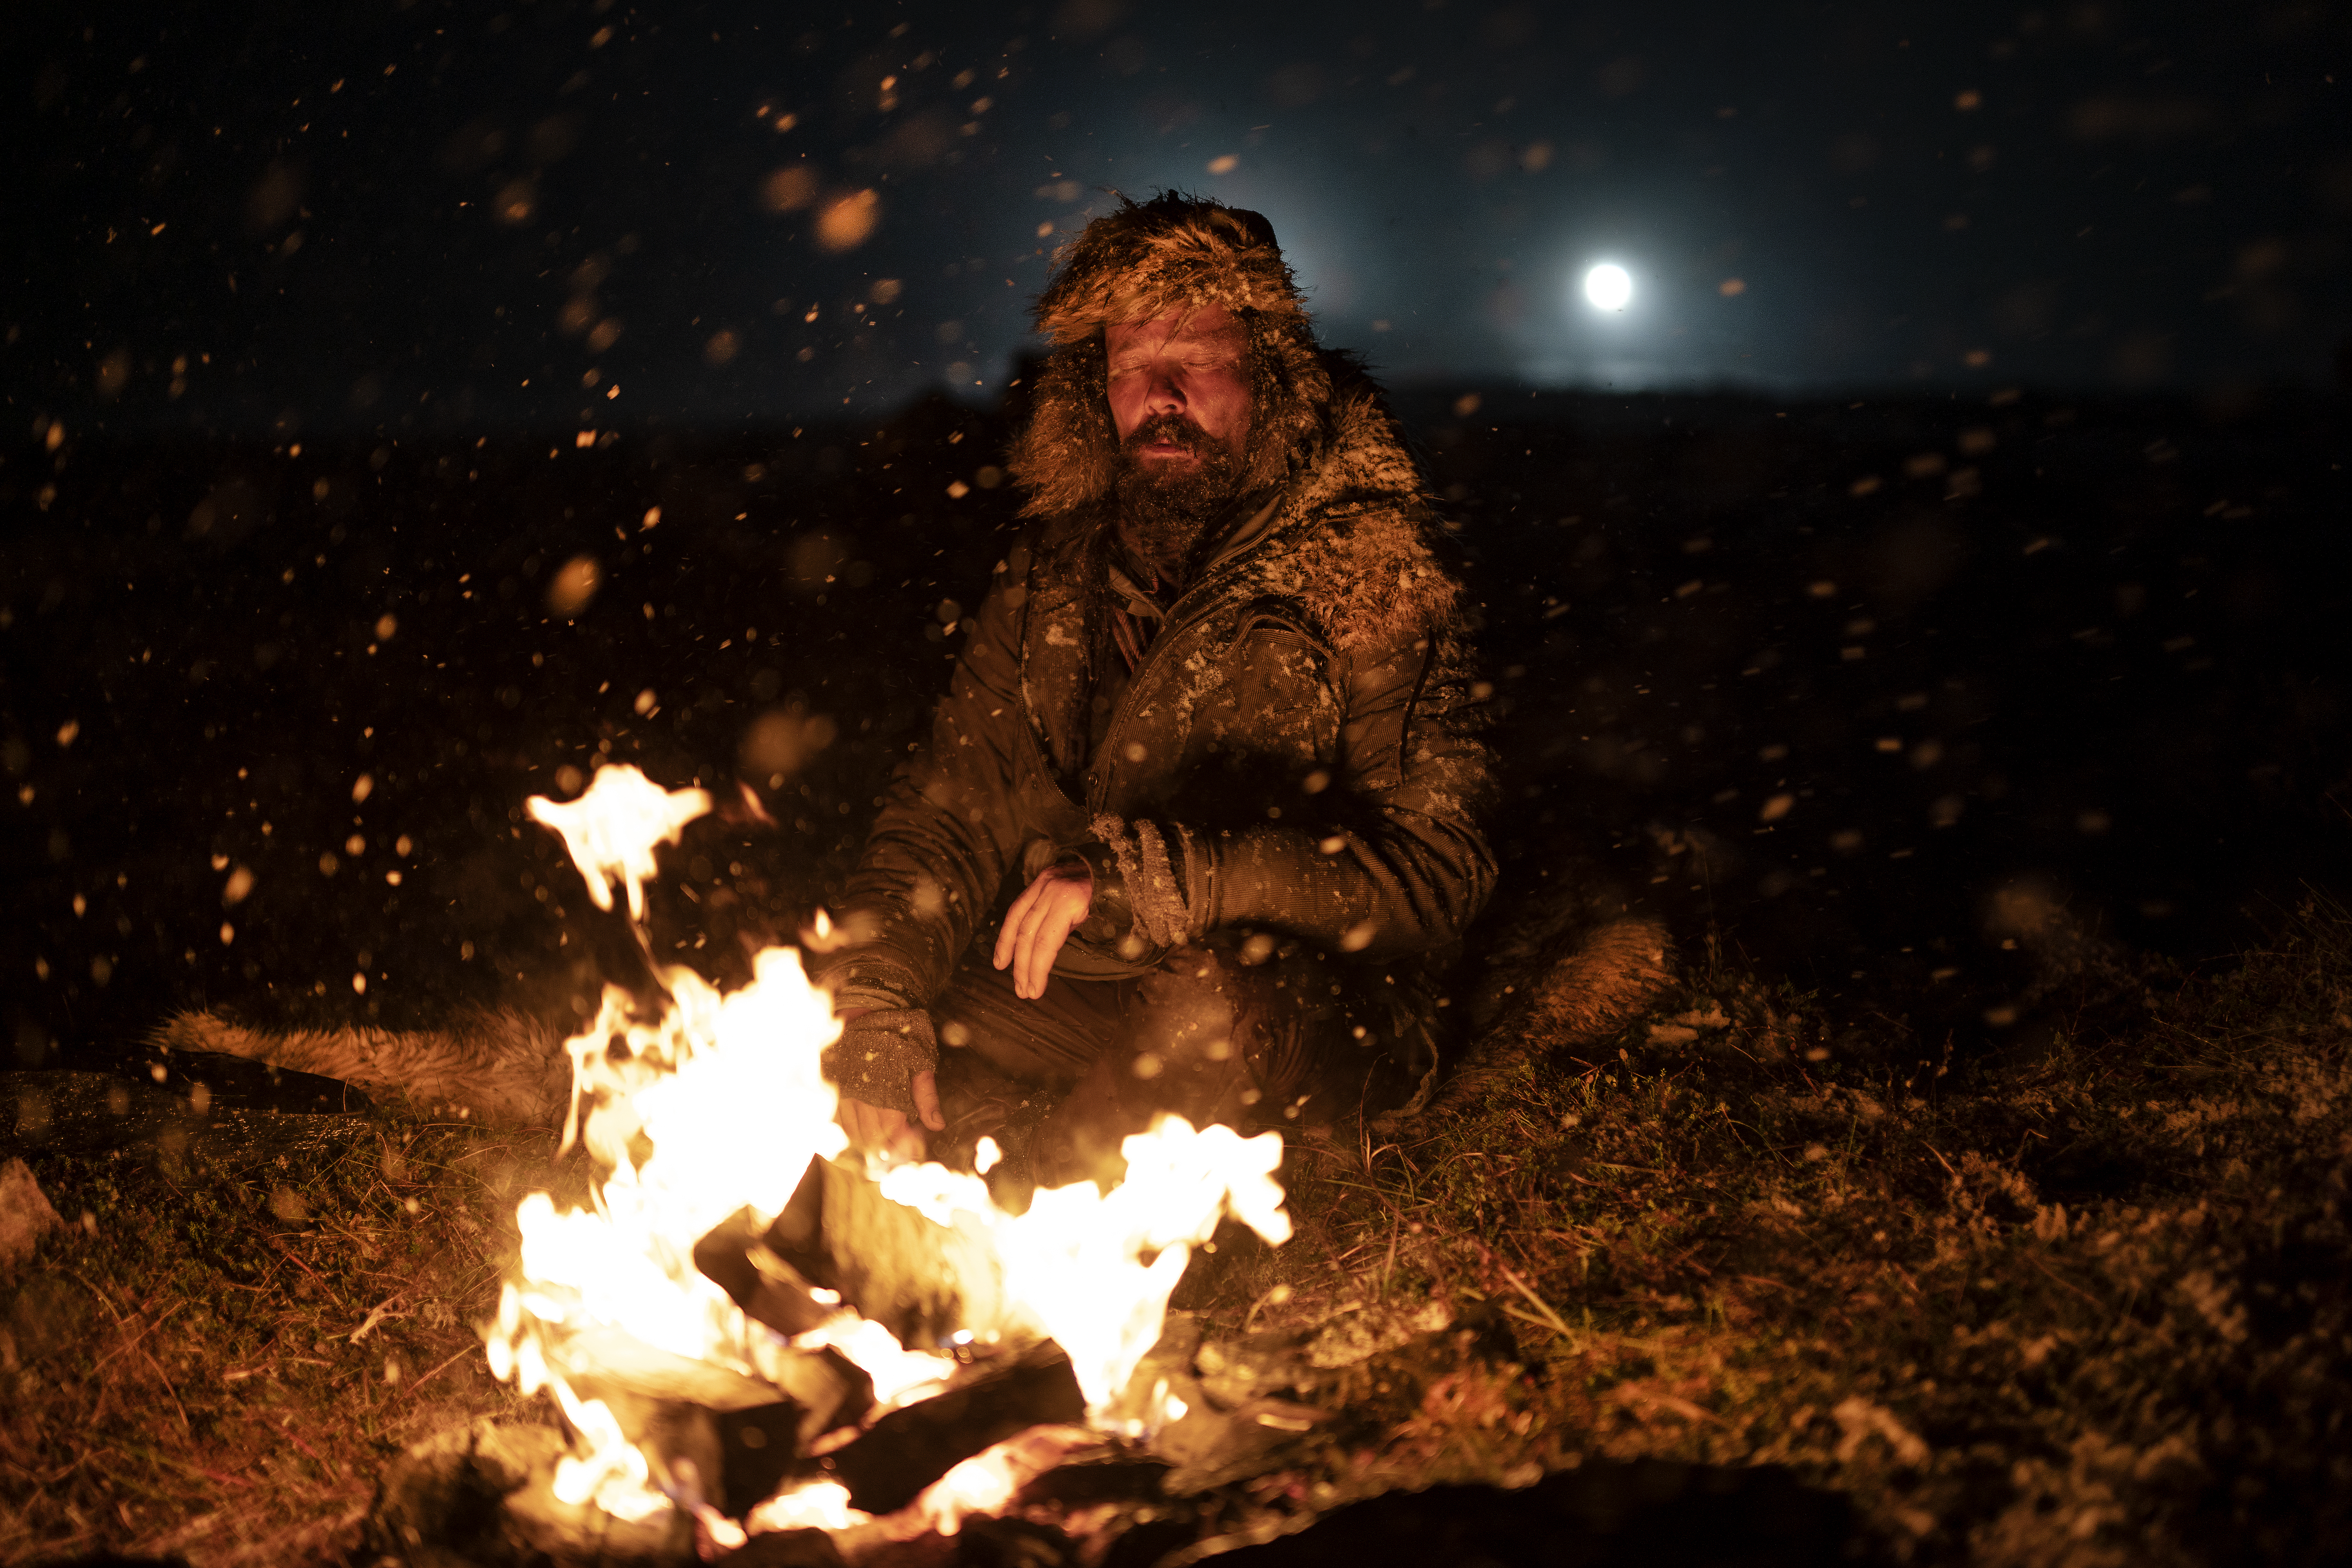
[151,1009,572,1126]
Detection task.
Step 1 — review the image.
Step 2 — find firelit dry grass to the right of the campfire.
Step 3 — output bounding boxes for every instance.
[1192,903,2352,1566]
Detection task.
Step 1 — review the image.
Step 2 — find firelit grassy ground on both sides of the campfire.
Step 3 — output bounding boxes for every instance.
[0,903,2352,1566]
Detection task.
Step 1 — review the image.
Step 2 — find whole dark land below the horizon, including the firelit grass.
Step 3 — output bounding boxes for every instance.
[0,386,2352,1563]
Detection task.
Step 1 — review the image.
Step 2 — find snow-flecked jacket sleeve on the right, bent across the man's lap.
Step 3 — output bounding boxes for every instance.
[1094,639,1496,959]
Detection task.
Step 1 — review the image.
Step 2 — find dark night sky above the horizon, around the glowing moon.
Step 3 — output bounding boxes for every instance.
[0,0,2352,435]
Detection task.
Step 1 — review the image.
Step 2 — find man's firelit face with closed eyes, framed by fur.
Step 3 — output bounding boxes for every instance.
[1103,306,1249,472]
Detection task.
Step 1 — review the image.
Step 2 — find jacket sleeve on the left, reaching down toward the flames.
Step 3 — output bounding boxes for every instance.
[818,543,1028,1009]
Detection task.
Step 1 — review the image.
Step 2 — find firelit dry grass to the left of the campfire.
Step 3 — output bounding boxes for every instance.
[0,1117,553,1568]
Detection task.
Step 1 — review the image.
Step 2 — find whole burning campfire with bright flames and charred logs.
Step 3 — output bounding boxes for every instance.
[445,766,1289,1559]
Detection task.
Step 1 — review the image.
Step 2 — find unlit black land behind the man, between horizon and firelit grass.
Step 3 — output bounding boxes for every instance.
[0,388,2352,1065]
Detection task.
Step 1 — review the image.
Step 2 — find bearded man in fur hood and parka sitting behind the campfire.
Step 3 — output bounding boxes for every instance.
[821,193,1494,1185]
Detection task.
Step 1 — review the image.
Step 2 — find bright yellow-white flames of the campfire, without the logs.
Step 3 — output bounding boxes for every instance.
[485,766,1289,1544]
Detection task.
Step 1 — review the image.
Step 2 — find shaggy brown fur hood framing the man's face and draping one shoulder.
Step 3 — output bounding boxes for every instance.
[1009,193,1461,649]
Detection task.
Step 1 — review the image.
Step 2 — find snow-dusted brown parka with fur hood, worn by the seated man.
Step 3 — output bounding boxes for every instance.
[826,198,1494,1128]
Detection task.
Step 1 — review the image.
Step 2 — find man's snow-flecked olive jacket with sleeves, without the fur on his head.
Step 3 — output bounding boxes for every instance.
[826,362,1494,1048]
